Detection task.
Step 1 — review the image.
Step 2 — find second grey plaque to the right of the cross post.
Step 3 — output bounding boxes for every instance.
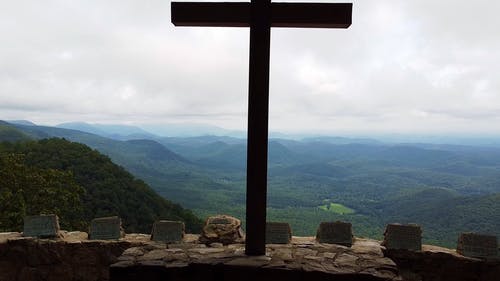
[316,221,353,247]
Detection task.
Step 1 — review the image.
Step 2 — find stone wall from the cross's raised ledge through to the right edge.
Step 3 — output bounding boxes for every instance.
[110,234,500,281]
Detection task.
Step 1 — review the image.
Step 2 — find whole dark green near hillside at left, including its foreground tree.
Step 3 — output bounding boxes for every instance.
[0,139,201,233]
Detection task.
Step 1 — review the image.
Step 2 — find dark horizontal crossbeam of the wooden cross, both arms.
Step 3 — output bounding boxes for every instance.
[172,2,352,28]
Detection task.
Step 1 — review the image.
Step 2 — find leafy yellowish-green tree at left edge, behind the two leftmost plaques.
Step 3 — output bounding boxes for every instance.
[0,152,85,231]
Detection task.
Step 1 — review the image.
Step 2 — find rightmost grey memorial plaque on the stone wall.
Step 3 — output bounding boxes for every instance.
[457,233,498,258]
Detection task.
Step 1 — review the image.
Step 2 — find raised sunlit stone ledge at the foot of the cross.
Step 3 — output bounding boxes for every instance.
[111,237,402,281]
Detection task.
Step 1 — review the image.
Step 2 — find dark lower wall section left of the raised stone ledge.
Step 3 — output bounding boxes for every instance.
[0,233,146,281]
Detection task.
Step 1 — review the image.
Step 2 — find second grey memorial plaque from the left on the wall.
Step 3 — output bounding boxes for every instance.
[89,217,124,240]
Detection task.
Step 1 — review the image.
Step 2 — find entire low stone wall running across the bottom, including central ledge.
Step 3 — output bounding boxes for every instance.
[0,232,500,281]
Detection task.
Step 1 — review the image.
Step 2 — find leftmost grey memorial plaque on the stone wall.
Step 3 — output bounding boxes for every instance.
[23,215,59,238]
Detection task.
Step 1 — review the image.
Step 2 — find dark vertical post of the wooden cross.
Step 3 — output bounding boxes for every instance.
[245,0,271,255]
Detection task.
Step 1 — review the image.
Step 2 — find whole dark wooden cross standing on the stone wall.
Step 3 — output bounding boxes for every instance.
[172,0,352,255]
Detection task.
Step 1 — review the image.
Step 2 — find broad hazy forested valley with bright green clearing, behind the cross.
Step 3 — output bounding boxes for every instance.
[159,133,500,247]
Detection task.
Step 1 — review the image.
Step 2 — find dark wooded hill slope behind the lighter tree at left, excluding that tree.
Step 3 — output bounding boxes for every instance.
[0,138,202,233]
